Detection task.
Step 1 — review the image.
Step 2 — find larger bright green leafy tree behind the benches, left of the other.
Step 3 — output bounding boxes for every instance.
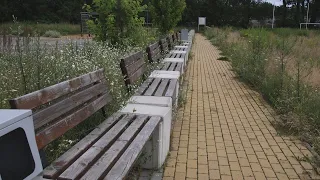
[86,0,145,44]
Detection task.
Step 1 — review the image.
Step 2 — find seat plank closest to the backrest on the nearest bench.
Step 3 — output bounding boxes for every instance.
[43,113,125,179]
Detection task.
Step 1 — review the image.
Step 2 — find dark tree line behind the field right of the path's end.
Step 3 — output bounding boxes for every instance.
[183,0,320,27]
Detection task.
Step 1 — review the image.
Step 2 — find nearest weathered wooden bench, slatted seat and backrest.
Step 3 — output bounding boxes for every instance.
[10,69,162,180]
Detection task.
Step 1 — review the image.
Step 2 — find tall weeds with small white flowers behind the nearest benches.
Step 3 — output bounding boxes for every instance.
[0,31,158,162]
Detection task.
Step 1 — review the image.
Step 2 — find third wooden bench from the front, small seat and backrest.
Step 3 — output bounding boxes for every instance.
[147,42,184,74]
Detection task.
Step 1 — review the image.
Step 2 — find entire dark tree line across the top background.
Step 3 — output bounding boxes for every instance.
[0,0,320,27]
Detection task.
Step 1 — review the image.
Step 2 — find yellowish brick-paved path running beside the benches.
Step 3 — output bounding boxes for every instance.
[164,34,320,180]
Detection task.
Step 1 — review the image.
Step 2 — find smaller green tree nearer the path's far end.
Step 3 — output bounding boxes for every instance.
[149,0,186,33]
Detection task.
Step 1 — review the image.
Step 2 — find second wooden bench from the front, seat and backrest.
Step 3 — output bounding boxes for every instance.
[121,50,179,106]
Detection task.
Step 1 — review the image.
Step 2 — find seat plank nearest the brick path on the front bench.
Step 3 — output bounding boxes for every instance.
[104,117,161,180]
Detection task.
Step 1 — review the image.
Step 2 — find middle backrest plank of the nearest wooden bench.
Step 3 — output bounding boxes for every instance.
[33,80,111,129]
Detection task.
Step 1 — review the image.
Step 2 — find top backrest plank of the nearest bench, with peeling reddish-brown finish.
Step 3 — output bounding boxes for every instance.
[9,69,104,109]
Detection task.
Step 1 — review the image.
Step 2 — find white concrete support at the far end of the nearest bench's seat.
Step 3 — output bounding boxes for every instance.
[121,104,172,169]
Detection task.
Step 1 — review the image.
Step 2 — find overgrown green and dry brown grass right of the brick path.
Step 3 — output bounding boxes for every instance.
[204,28,320,163]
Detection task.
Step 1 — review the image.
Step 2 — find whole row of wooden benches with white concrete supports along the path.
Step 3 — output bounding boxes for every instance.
[10,30,194,180]
